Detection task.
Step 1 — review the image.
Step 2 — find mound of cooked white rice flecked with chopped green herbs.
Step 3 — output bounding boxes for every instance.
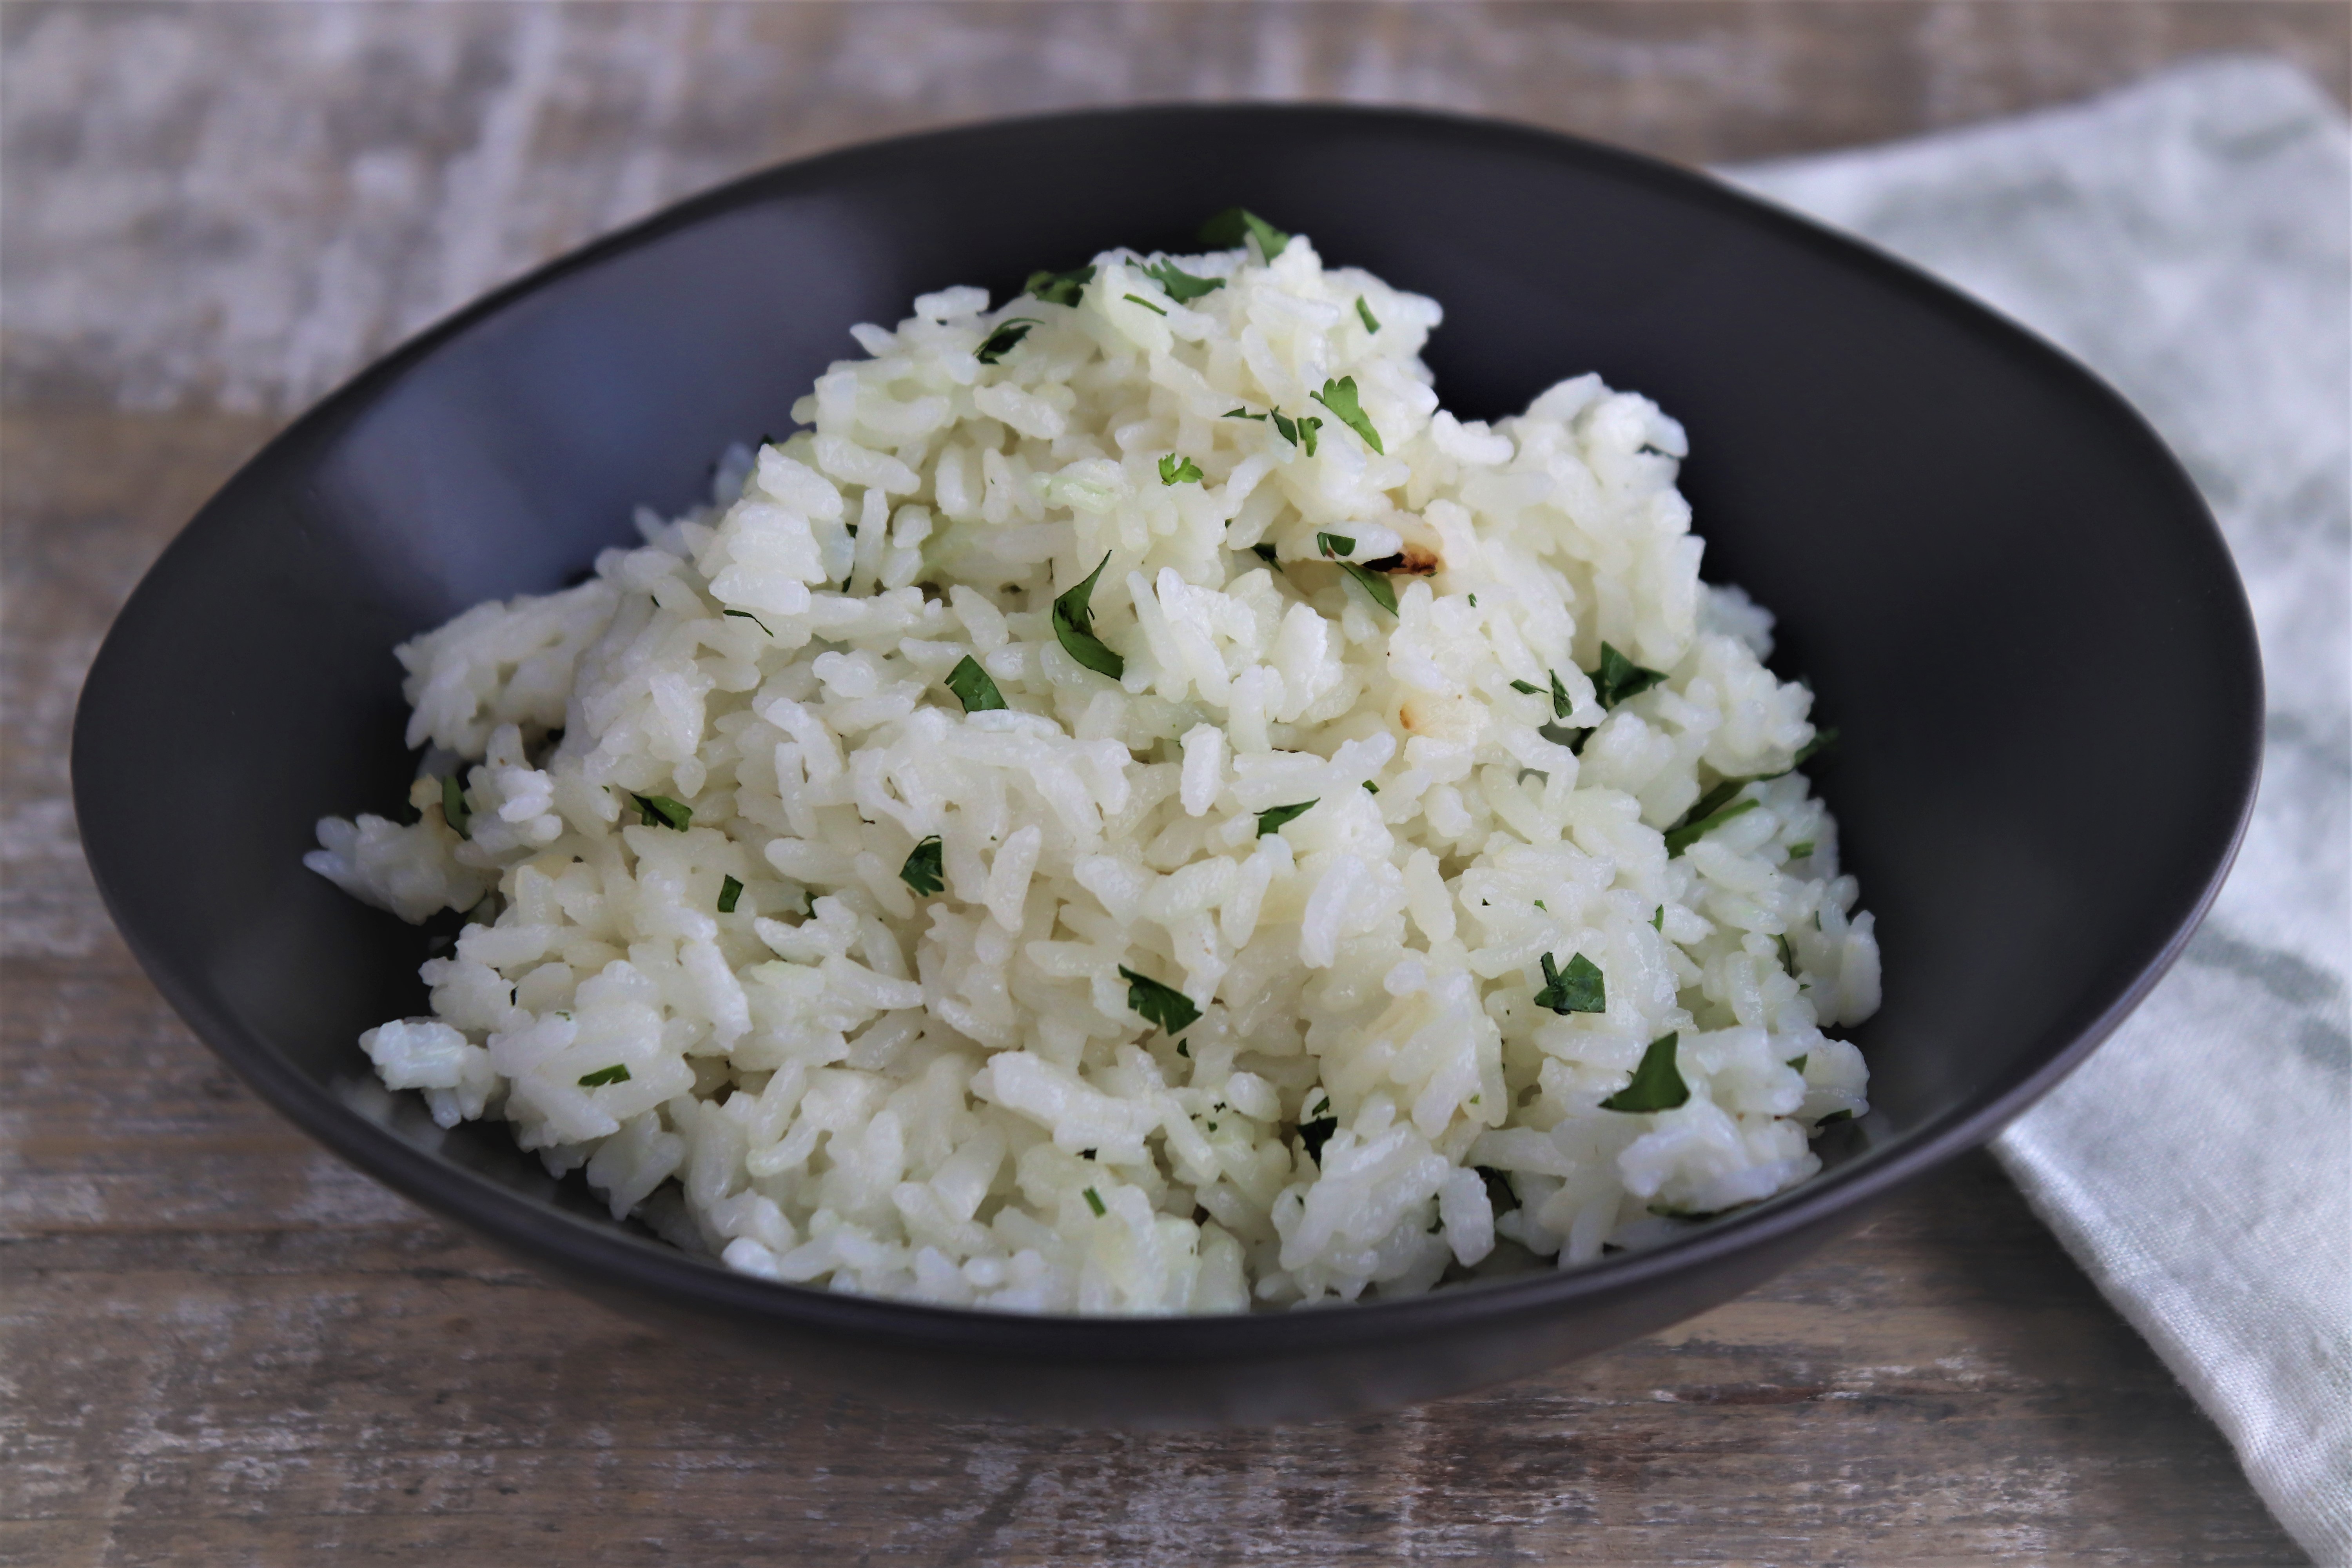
[306,235,1879,1312]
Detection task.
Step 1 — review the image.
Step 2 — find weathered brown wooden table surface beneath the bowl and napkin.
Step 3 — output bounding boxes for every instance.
[0,0,2352,1566]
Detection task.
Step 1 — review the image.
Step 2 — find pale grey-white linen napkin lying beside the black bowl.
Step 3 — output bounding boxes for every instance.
[1729,56,2352,1568]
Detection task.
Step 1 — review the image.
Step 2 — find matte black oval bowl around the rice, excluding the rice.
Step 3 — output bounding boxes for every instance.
[73,108,2263,1425]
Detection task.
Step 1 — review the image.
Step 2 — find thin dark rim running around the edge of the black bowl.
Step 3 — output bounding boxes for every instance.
[73,101,2263,1363]
